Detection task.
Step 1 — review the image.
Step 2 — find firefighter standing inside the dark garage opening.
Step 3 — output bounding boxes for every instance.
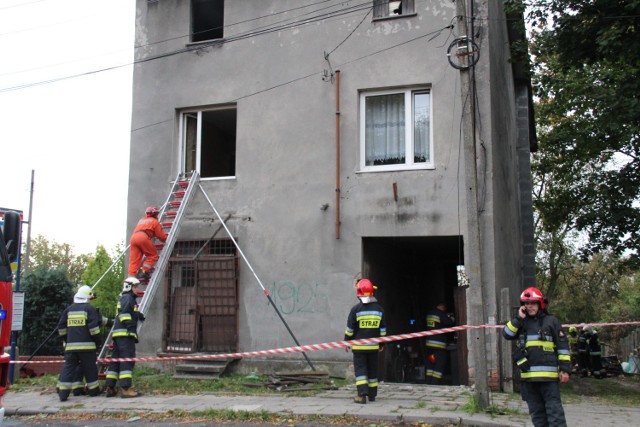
[425,303,455,384]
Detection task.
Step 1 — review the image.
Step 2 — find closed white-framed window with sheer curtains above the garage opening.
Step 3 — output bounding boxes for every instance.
[360,89,433,172]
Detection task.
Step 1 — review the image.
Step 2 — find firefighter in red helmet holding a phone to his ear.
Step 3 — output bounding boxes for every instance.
[502,287,571,427]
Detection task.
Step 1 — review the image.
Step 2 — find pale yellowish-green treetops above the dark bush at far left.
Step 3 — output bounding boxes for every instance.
[27,235,89,284]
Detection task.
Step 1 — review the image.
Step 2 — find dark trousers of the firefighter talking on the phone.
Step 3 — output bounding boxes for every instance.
[520,381,567,427]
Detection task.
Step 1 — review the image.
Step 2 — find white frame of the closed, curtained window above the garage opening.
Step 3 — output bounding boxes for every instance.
[359,86,435,172]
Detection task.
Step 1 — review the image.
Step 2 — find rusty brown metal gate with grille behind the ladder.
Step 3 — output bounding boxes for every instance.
[164,239,238,353]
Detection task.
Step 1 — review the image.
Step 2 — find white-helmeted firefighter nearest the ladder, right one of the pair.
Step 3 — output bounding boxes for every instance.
[105,277,144,398]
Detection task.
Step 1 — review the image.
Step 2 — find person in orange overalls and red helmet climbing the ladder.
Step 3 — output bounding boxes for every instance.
[128,206,167,279]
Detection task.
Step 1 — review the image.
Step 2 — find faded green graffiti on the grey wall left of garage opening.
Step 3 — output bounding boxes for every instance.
[268,280,329,315]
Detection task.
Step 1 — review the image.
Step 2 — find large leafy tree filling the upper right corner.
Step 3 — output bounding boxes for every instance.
[528,0,640,263]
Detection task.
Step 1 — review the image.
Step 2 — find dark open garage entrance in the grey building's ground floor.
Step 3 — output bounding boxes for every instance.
[362,236,468,385]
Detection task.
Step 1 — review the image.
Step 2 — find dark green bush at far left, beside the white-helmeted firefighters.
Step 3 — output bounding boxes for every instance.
[18,267,76,355]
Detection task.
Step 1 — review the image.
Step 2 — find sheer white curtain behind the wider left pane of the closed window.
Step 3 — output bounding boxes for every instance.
[365,93,405,166]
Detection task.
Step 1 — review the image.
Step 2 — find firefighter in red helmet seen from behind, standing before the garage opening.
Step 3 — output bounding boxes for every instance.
[344,279,387,404]
